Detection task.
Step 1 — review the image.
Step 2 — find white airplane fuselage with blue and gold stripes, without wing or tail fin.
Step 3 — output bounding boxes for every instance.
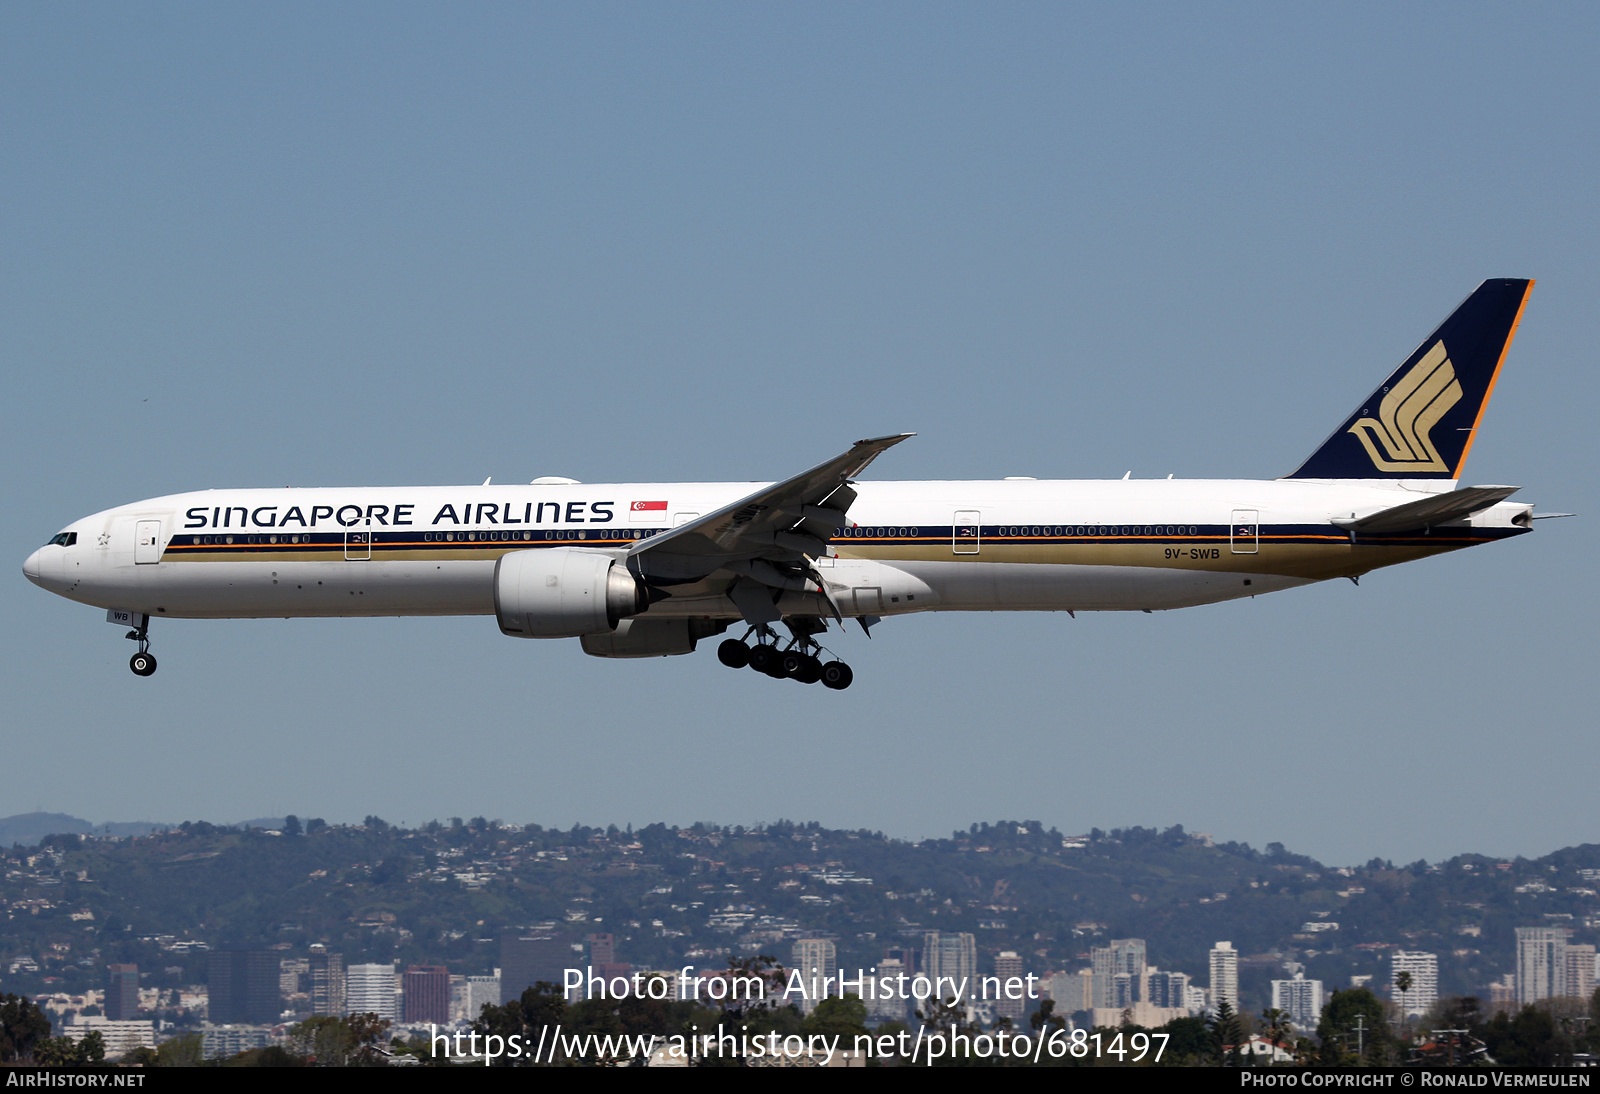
[24,480,1530,619]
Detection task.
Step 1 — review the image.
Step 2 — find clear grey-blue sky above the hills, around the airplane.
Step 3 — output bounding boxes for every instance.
[0,3,1600,862]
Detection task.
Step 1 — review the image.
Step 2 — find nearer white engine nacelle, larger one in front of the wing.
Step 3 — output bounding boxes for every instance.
[494,547,650,638]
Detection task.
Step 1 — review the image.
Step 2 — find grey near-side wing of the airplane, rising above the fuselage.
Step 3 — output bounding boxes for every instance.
[627,433,915,589]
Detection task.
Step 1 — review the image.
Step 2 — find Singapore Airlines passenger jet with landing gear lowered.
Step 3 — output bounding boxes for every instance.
[22,278,1566,689]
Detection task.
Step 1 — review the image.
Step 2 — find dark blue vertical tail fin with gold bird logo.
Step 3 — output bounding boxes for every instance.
[1286,278,1533,480]
